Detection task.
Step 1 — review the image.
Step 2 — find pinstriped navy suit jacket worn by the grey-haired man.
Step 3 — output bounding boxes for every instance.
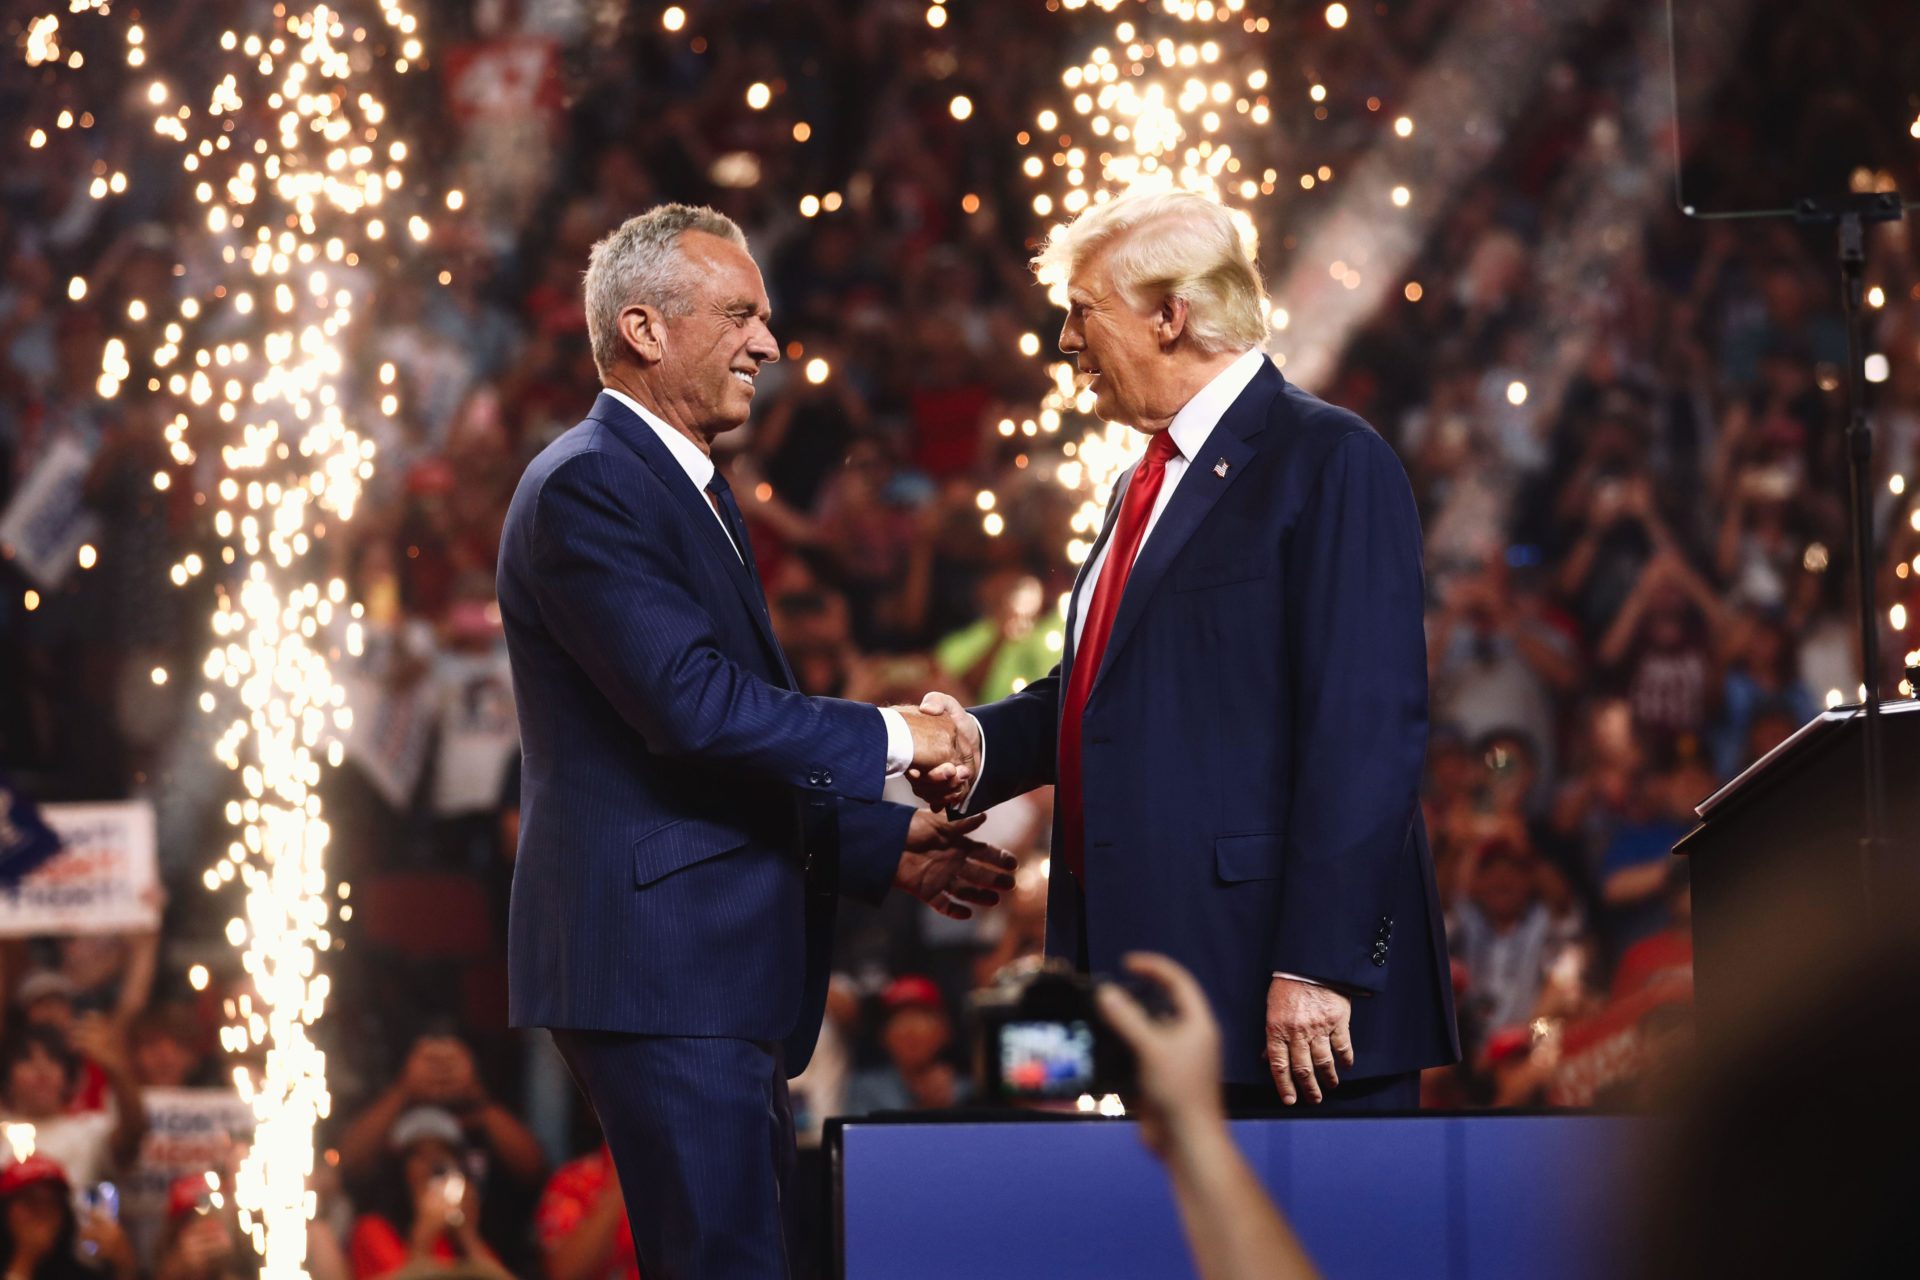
[499,395,912,1073]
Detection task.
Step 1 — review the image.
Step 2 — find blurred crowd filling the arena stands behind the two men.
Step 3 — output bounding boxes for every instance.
[0,0,1920,1278]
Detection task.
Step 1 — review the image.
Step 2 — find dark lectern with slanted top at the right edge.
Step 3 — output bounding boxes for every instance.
[1674,700,1920,1027]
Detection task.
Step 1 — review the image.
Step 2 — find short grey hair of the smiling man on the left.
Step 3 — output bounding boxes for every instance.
[586,205,747,378]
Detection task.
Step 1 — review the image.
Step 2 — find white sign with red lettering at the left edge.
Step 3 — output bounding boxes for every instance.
[0,800,159,936]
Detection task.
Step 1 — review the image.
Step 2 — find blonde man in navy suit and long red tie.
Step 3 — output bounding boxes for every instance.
[922,192,1459,1111]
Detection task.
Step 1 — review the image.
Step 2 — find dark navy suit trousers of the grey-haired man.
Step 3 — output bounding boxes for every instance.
[553,1031,795,1280]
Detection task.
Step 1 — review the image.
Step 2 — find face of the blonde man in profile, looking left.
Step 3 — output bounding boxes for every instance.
[1060,248,1185,432]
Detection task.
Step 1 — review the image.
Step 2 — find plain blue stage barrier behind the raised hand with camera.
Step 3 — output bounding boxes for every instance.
[837,1113,1647,1280]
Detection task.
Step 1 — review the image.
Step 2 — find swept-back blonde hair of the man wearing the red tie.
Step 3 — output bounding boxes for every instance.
[1033,190,1267,355]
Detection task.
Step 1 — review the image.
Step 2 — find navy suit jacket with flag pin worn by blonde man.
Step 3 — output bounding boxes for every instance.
[970,363,1459,1082]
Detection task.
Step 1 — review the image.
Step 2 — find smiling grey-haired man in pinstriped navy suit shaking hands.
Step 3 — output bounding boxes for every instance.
[499,205,1014,1280]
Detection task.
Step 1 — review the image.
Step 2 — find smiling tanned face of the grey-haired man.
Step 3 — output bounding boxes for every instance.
[620,230,780,447]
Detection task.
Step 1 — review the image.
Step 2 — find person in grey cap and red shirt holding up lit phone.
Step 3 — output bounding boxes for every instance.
[348,1107,511,1280]
